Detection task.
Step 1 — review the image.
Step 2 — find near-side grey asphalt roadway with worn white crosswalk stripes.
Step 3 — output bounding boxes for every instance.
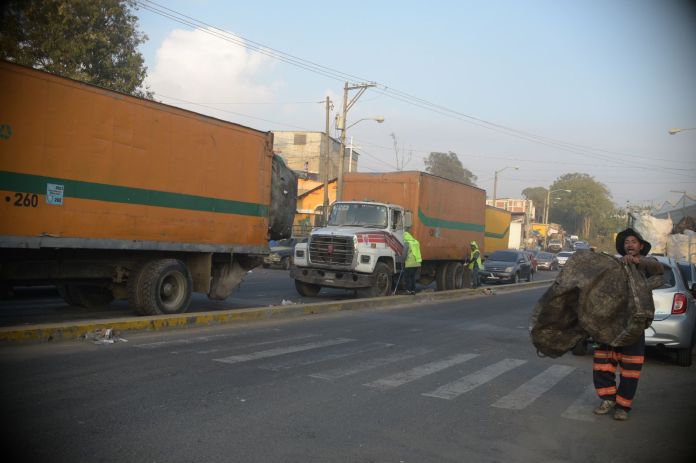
[0,288,696,463]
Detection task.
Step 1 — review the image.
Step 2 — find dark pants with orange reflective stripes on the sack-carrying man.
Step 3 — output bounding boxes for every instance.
[592,335,645,411]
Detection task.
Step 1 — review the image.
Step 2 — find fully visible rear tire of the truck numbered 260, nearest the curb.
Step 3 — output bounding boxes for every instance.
[133,259,193,315]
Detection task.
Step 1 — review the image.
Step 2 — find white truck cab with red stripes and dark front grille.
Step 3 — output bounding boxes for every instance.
[290,201,412,297]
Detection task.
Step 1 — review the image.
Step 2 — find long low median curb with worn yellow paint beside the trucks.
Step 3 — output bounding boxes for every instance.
[0,280,553,342]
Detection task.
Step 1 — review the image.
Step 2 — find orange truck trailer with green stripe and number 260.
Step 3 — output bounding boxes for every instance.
[0,62,297,315]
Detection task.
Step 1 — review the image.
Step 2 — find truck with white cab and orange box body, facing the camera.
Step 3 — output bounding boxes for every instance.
[290,171,486,297]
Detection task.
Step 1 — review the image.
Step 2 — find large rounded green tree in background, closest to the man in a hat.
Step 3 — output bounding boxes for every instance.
[549,173,616,238]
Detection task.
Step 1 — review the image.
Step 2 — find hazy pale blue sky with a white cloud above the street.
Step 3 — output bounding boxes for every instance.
[137,0,696,206]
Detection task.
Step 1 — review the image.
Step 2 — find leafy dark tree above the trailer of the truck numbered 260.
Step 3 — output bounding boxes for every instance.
[0,0,152,98]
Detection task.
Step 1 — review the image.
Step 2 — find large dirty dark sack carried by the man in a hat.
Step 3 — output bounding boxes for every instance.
[530,251,662,358]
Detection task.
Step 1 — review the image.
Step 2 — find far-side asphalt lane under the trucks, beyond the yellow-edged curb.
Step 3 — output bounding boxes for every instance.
[0,267,558,326]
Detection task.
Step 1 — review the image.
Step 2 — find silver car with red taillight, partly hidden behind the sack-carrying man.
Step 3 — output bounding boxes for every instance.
[645,256,696,367]
